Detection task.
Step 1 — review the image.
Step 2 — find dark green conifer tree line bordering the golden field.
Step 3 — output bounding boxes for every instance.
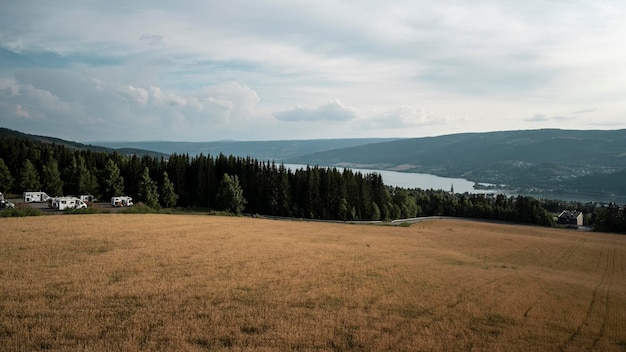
[0,138,623,230]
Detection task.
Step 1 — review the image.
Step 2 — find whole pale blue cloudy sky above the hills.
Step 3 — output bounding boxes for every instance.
[0,0,626,142]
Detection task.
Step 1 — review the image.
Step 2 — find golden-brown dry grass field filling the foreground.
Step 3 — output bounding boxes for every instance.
[0,214,626,351]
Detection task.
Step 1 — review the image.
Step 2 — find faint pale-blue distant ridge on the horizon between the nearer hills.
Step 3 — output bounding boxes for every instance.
[90,138,398,162]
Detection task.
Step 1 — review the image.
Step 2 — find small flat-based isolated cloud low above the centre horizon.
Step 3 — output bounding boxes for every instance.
[274,99,358,122]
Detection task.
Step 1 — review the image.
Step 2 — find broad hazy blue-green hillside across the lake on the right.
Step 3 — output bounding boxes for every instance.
[287,129,626,195]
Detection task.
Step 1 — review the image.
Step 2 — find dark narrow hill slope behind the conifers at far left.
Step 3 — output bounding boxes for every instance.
[0,127,168,158]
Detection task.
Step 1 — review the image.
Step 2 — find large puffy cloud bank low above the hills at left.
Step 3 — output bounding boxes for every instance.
[0,64,260,140]
